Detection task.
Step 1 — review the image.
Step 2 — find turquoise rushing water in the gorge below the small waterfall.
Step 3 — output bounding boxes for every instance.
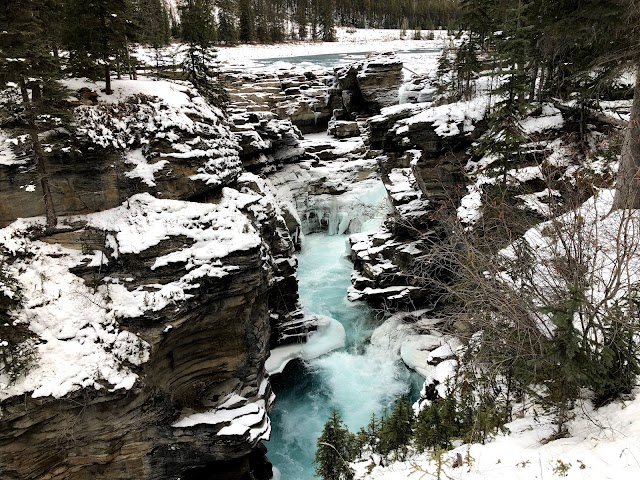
[267,234,421,480]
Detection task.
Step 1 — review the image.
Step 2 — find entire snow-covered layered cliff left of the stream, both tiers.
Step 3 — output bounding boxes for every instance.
[0,81,310,480]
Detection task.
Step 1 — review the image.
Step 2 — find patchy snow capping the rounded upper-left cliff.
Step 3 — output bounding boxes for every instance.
[64,78,242,187]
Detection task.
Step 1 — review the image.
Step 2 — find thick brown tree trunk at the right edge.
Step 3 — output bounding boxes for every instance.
[613,64,640,209]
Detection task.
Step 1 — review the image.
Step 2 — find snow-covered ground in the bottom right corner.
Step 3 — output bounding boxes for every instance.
[356,390,640,480]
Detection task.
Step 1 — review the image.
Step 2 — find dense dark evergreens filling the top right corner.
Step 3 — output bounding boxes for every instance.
[436,0,640,208]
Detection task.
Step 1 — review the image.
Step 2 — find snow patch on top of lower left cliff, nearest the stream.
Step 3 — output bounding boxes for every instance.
[83,188,260,317]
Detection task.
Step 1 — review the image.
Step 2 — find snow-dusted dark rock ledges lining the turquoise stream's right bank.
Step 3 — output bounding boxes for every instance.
[349,99,484,309]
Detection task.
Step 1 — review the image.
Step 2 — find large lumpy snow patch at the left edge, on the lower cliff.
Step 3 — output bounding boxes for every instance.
[0,220,149,400]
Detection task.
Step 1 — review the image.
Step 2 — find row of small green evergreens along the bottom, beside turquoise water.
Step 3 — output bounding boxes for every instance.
[314,381,510,480]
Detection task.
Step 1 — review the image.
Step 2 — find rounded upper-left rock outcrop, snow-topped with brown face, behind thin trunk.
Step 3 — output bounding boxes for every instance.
[0,80,242,226]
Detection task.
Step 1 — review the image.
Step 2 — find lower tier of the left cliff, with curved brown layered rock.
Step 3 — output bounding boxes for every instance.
[0,189,280,480]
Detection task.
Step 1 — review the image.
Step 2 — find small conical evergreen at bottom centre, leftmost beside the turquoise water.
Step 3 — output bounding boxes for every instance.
[314,410,355,480]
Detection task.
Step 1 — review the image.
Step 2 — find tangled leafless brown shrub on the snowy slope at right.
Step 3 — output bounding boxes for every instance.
[412,188,640,435]
